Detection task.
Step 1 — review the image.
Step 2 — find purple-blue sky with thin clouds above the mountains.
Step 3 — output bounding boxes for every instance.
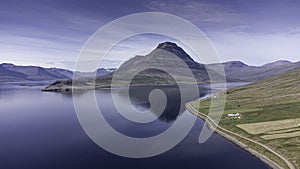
[0,0,300,69]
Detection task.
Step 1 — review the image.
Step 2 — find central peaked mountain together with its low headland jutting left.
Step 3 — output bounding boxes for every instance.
[45,42,233,91]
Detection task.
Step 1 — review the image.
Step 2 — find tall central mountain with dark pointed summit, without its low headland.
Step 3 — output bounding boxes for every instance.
[112,42,225,84]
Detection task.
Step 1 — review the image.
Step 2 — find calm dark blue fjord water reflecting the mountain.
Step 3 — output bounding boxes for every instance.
[0,85,268,169]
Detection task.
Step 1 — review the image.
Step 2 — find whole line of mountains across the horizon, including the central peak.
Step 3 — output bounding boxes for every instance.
[0,42,300,91]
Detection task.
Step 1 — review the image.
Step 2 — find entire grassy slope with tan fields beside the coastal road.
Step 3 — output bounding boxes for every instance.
[193,69,300,168]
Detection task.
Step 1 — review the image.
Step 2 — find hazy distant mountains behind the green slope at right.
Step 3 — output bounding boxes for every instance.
[206,60,300,82]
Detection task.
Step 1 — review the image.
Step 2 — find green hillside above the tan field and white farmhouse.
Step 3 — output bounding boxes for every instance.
[221,69,300,122]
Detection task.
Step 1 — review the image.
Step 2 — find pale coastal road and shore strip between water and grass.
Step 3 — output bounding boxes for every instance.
[185,102,295,169]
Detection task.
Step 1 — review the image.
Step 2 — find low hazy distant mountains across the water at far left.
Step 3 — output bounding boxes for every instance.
[0,63,114,82]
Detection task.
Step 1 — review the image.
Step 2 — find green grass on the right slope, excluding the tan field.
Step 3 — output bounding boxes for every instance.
[193,69,300,168]
